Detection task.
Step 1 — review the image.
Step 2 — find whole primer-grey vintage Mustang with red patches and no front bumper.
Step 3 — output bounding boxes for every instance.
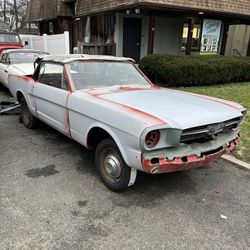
[9,55,246,191]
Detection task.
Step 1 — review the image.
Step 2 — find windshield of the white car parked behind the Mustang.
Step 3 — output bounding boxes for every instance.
[7,52,47,64]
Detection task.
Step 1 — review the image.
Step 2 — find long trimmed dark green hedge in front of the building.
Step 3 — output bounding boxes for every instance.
[139,55,250,86]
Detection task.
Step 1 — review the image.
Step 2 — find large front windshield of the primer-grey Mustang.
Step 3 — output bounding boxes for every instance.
[68,61,151,90]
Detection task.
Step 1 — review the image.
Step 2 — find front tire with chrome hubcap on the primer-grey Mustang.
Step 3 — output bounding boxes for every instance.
[95,139,131,192]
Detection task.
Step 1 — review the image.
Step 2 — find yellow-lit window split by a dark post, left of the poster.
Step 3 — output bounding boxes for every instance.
[182,23,202,53]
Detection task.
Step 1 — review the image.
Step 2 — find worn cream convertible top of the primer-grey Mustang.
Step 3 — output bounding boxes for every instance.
[42,54,135,64]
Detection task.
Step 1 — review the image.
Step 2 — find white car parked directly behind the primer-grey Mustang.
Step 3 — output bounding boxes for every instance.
[0,49,48,88]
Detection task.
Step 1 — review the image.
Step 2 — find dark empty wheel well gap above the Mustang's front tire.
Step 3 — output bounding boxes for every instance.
[87,127,113,149]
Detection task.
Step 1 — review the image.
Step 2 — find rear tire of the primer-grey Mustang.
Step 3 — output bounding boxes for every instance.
[20,97,38,129]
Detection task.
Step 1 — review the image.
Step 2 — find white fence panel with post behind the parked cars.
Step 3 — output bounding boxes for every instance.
[20,31,70,55]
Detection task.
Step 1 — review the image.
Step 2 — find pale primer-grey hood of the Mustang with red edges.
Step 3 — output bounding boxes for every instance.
[89,88,243,129]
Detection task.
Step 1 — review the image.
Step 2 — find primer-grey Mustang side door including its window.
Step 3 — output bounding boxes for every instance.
[33,63,70,135]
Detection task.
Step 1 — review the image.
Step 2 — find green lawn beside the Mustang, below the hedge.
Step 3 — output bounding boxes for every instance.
[167,82,250,162]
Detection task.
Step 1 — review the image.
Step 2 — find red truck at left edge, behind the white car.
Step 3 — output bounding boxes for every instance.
[0,31,23,55]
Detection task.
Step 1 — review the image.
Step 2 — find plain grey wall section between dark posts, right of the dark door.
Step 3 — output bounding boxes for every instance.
[154,17,184,55]
